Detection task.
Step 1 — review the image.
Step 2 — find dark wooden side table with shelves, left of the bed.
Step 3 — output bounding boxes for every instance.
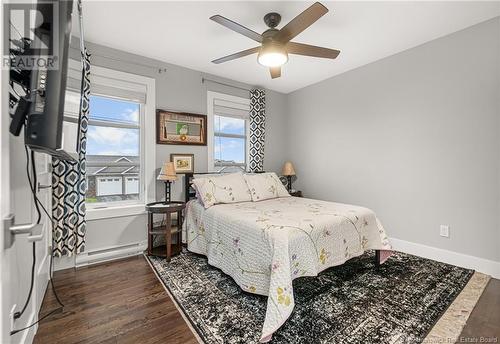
[146,202,186,261]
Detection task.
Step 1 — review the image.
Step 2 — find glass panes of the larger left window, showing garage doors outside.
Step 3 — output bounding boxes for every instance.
[86,95,143,204]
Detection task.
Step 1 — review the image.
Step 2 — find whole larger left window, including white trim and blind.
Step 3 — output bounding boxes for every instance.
[75,66,156,220]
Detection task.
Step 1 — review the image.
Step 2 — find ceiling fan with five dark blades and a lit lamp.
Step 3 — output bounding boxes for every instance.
[210,2,340,79]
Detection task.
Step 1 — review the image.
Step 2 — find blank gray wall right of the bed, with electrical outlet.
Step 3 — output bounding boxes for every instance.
[286,17,500,261]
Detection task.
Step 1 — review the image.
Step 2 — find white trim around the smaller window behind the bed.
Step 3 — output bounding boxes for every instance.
[207,91,250,172]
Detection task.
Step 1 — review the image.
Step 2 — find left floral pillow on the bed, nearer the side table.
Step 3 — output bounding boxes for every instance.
[193,173,252,208]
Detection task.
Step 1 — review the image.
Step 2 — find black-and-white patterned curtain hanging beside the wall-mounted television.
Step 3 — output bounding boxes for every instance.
[52,49,90,257]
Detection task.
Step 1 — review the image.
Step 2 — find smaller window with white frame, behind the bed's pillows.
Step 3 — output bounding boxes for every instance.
[208,92,250,171]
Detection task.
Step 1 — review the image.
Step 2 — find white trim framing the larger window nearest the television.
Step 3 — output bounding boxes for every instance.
[86,66,156,221]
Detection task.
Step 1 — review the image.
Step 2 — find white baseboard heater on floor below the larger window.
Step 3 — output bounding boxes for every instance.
[75,241,147,267]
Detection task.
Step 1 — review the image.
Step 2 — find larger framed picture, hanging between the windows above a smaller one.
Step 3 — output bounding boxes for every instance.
[156,110,207,146]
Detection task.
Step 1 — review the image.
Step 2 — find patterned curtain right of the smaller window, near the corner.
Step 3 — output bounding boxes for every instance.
[249,89,266,172]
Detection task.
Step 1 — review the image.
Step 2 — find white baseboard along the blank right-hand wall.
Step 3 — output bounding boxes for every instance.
[390,238,500,279]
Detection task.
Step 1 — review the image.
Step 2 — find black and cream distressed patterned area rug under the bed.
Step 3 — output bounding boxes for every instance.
[147,252,474,344]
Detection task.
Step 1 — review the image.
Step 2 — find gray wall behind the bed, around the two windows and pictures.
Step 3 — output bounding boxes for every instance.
[71,42,286,250]
